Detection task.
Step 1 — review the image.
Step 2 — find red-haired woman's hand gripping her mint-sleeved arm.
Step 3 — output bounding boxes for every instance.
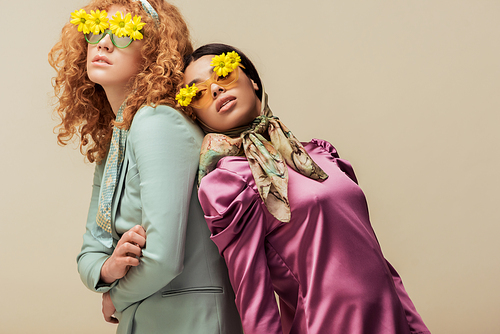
[101,225,146,284]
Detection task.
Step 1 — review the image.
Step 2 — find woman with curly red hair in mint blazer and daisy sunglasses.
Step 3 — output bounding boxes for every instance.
[49,0,241,334]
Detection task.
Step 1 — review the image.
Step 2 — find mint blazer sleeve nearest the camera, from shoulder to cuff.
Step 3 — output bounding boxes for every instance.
[110,106,201,312]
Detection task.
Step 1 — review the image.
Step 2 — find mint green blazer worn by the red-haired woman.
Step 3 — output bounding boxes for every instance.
[77,106,242,334]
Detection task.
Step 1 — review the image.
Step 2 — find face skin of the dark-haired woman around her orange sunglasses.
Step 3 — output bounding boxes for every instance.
[184,55,261,132]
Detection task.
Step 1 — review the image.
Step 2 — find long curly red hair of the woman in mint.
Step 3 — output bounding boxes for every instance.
[49,0,193,162]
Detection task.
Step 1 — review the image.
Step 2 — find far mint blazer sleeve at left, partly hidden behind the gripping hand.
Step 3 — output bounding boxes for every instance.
[77,161,113,292]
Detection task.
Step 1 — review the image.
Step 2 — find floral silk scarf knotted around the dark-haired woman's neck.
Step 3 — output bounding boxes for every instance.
[198,94,328,222]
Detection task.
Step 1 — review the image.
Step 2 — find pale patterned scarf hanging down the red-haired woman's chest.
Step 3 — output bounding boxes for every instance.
[91,102,128,248]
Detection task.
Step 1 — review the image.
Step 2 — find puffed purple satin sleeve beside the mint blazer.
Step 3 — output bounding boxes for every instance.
[198,163,282,334]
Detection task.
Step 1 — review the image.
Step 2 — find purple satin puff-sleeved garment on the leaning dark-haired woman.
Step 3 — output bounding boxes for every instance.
[199,139,430,334]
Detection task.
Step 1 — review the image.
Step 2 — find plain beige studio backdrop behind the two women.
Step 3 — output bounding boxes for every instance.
[0,0,500,334]
